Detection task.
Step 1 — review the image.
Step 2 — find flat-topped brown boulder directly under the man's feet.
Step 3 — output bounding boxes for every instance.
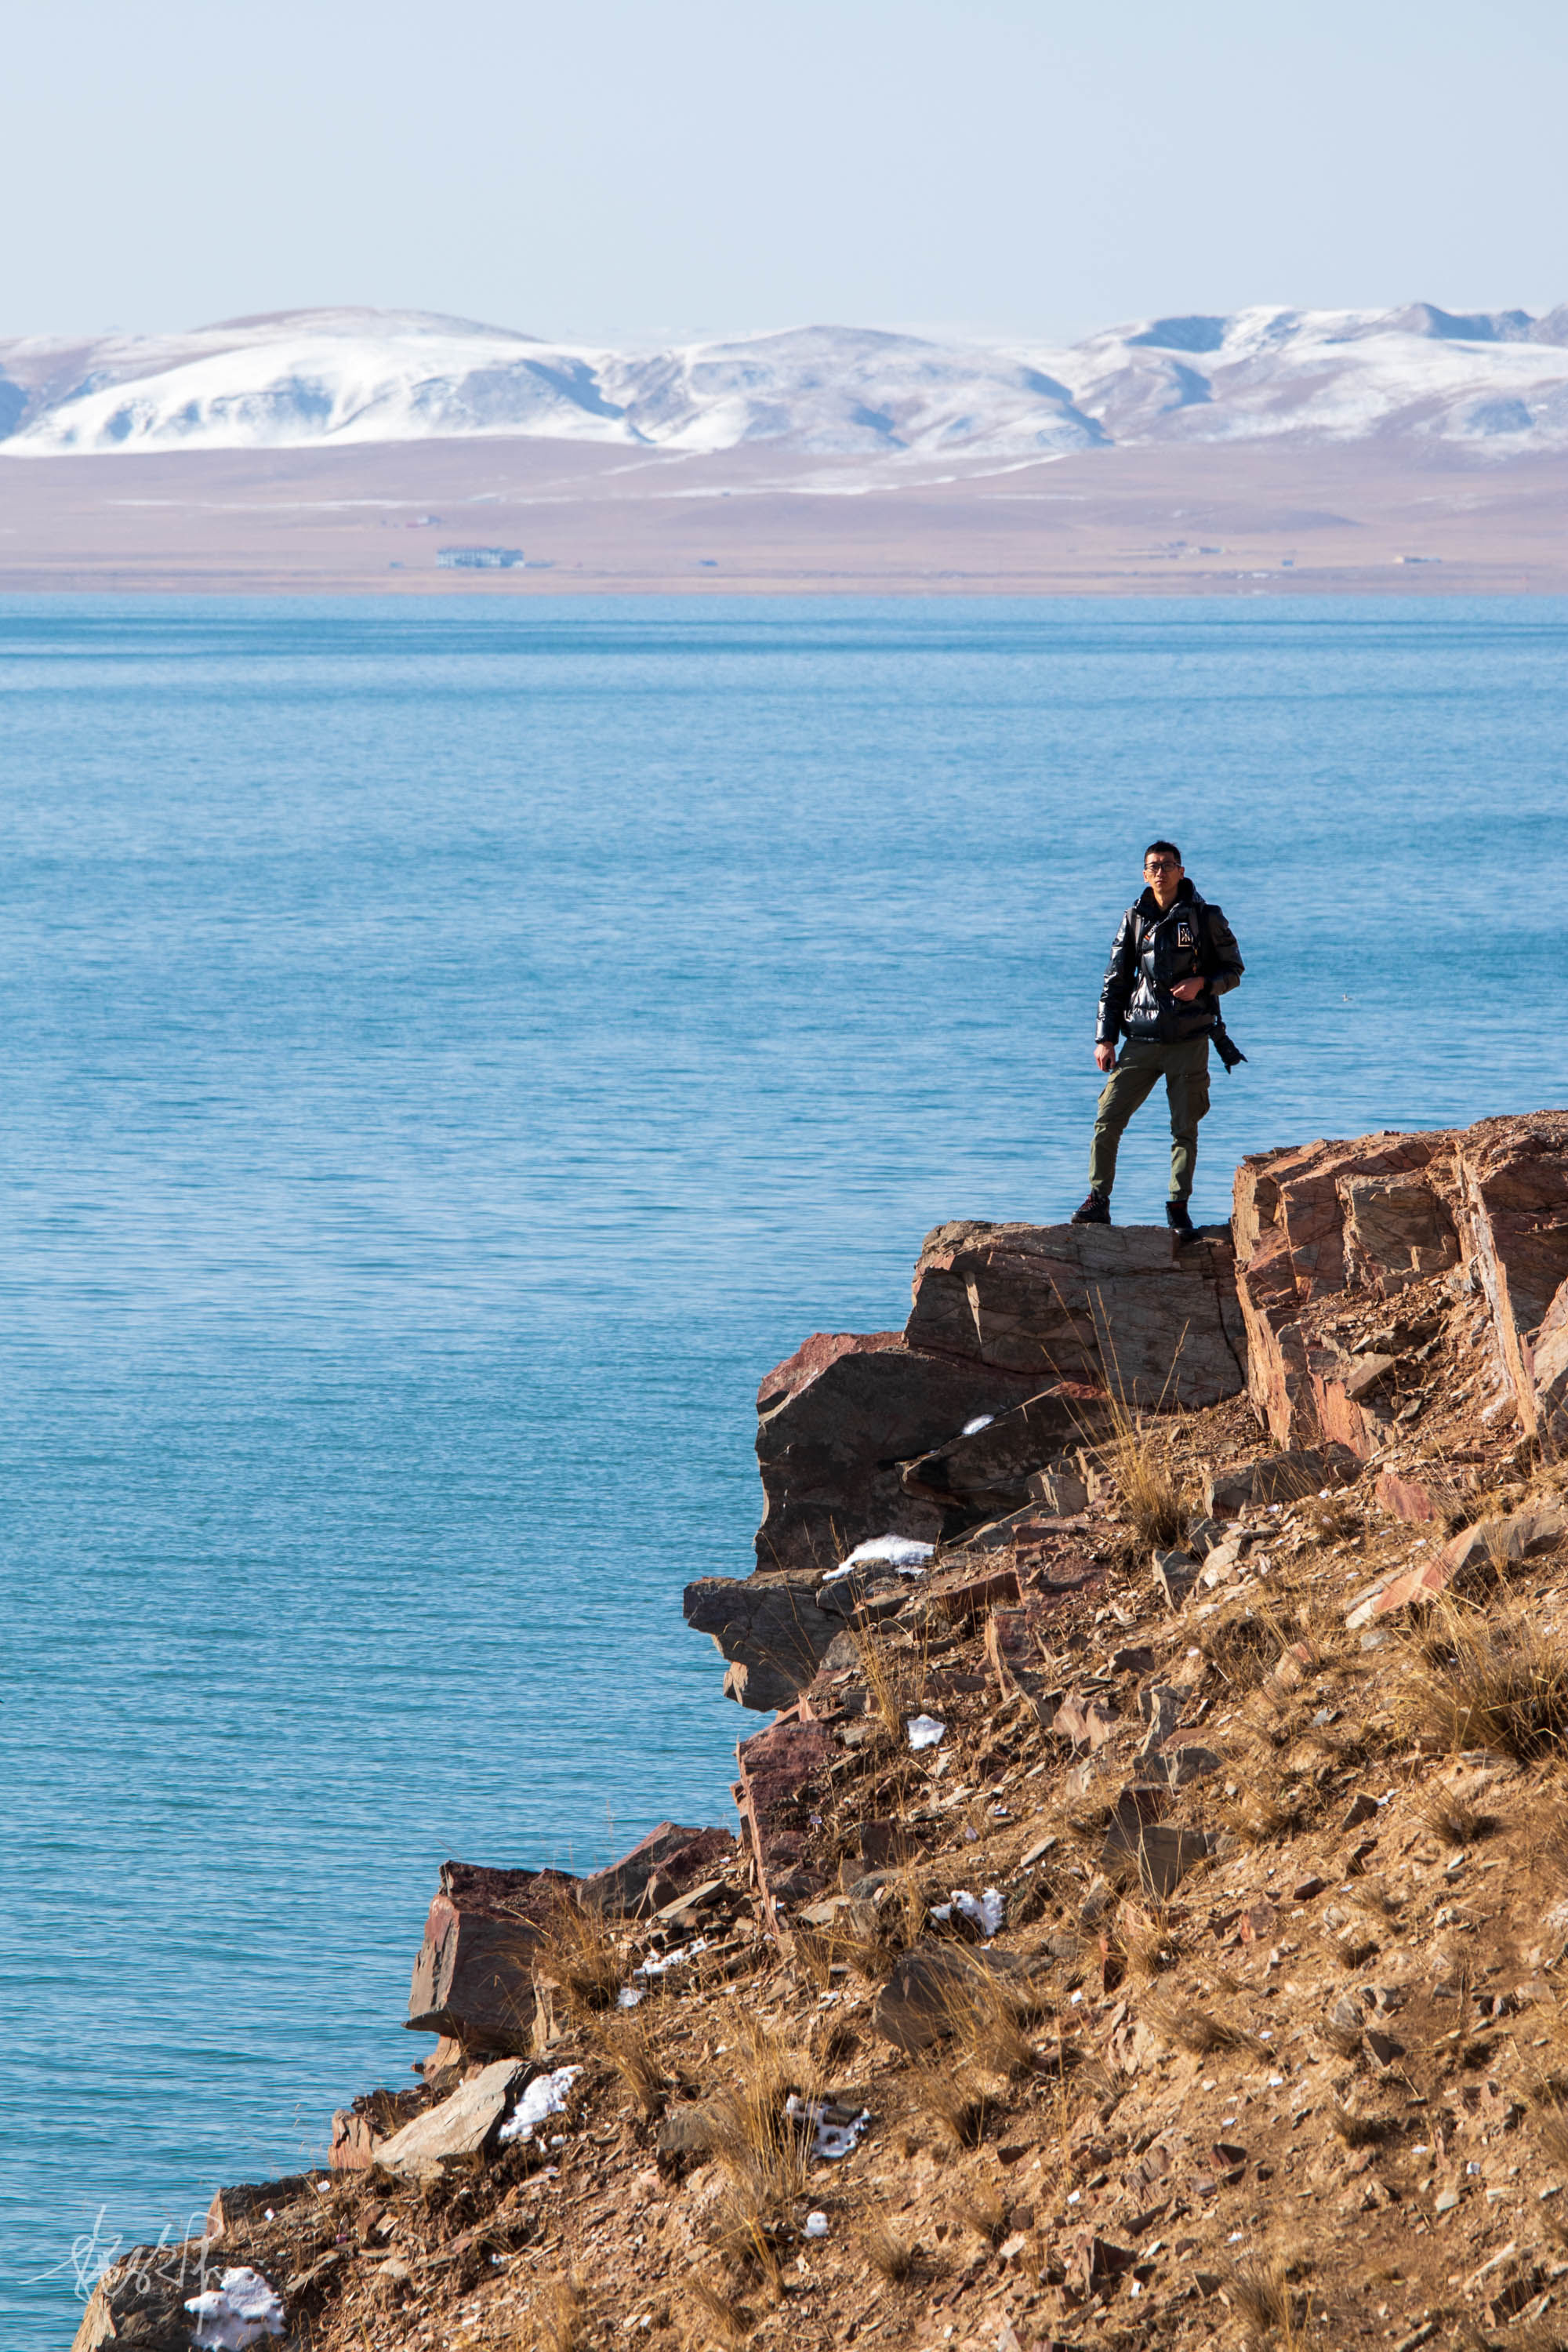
[905,1221,1243,1409]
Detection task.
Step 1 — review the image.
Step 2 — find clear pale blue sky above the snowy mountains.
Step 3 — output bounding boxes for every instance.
[0,0,1568,341]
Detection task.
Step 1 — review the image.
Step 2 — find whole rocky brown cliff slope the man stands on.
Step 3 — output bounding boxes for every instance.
[78,1112,1568,2352]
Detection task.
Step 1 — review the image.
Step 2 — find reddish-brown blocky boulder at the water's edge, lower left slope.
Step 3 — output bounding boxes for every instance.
[405,1863,581,2053]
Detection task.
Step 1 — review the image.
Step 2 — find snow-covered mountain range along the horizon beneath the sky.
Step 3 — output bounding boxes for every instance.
[0,303,1568,461]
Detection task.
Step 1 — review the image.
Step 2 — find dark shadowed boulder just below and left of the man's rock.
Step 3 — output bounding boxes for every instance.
[757,1331,1041,1571]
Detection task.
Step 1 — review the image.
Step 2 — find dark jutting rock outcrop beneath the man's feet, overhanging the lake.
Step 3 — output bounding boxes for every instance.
[687,1221,1246,1708]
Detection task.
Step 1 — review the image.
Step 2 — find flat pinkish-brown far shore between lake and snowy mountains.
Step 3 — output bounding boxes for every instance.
[0,437,1568,597]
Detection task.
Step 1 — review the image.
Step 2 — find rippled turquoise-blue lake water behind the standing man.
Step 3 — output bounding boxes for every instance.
[0,597,1568,2352]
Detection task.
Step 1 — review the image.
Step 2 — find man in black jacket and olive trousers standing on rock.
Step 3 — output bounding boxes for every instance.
[1072,842,1243,1232]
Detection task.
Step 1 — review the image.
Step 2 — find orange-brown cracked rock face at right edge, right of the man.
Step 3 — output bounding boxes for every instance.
[1234,1110,1568,1461]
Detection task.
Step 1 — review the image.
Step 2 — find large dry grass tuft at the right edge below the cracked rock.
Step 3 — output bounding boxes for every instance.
[1399,1602,1568,1764]
